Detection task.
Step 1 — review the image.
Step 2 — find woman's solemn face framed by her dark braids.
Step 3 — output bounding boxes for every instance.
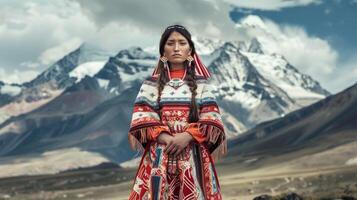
[164,31,191,64]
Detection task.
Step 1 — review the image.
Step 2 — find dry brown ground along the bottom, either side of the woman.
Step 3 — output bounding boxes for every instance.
[0,165,357,200]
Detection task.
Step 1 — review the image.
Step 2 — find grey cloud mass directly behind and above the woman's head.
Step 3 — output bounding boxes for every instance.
[73,0,243,45]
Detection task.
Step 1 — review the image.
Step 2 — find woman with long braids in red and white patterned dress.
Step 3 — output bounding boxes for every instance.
[129,25,227,200]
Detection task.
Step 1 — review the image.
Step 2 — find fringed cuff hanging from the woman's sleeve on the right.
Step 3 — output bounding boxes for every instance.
[199,124,227,161]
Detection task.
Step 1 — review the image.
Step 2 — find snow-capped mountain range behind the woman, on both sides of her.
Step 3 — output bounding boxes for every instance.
[0,38,327,177]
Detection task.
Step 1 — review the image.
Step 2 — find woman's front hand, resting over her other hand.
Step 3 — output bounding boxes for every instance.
[164,132,193,157]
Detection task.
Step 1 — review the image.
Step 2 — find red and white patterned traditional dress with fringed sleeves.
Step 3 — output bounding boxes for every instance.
[129,65,227,200]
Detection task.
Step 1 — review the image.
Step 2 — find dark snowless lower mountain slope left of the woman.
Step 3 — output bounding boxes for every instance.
[0,82,140,176]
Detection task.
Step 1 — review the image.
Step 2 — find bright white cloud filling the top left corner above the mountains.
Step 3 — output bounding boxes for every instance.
[0,0,96,82]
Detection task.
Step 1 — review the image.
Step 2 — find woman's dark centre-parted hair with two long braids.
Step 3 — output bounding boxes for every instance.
[157,24,198,123]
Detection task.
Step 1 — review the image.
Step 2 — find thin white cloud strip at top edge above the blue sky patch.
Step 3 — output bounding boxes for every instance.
[223,0,321,10]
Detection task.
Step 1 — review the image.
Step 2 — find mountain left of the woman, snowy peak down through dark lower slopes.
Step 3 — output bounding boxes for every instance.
[0,47,157,175]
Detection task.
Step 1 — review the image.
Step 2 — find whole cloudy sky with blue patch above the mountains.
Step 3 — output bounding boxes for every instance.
[0,0,357,93]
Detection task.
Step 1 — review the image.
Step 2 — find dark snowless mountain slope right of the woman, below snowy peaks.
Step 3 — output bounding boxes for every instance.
[224,83,357,171]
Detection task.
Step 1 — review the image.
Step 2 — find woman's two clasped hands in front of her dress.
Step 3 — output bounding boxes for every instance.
[157,124,193,157]
